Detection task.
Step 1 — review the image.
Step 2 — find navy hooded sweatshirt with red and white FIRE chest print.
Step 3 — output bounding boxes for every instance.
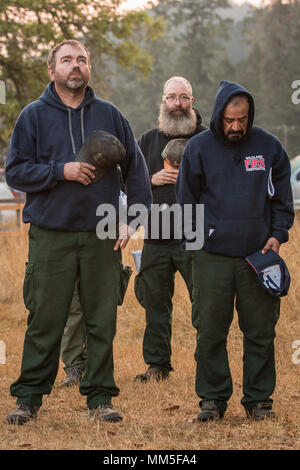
[176,81,294,256]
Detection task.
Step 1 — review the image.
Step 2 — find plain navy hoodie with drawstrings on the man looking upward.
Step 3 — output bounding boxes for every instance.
[5,82,152,232]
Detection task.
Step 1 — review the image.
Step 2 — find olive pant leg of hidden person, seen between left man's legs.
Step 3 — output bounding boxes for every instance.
[60,281,87,370]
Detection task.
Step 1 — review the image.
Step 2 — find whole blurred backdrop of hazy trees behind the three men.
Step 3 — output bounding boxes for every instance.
[0,0,300,162]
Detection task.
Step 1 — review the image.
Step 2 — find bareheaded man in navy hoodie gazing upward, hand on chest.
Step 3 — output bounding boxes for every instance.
[6,40,152,424]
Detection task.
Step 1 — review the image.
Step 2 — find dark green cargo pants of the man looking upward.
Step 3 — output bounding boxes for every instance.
[11,225,121,408]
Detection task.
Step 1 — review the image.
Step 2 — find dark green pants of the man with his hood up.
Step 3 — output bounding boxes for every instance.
[193,250,280,413]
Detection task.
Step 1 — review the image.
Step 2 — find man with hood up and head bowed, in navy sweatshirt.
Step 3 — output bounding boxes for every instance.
[176,81,294,422]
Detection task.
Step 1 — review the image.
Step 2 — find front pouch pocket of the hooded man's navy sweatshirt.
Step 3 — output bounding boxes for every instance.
[204,217,270,256]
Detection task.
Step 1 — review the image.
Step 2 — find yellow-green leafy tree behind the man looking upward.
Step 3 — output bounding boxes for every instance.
[0,0,163,162]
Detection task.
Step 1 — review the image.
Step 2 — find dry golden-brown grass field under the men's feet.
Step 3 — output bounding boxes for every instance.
[0,214,300,450]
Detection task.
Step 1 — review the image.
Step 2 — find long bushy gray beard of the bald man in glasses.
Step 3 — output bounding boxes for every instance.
[158,103,197,135]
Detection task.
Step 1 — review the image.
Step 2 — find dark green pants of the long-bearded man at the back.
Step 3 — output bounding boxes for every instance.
[135,243,192,372]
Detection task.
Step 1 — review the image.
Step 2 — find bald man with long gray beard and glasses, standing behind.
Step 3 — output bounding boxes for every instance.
[135,76,206,382]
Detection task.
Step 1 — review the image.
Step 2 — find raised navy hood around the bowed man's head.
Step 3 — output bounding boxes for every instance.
[209,80,255,139]
